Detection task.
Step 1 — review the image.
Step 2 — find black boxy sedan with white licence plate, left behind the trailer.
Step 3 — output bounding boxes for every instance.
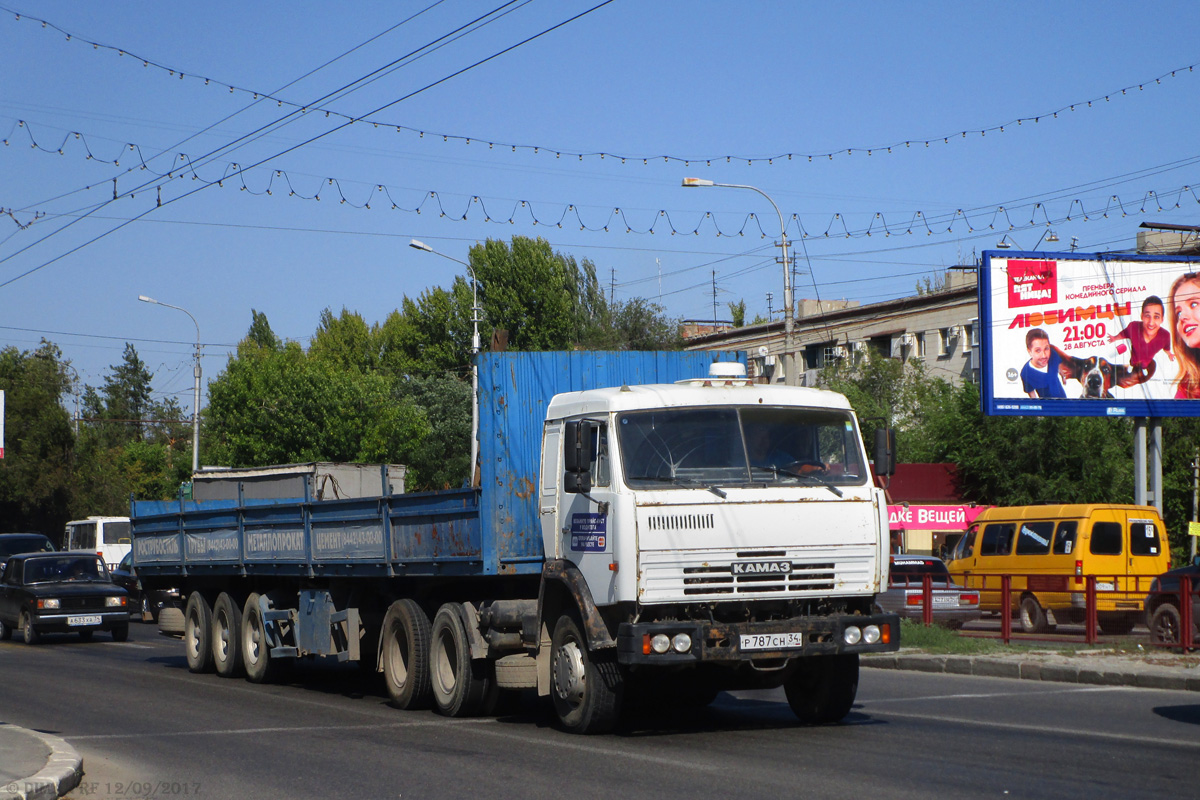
[0,551,130,644]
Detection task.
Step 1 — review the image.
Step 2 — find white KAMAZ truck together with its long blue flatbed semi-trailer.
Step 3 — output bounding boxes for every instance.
[130,351,899,733]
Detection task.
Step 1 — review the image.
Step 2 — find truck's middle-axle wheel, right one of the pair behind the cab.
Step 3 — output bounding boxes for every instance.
[430,603,493,717]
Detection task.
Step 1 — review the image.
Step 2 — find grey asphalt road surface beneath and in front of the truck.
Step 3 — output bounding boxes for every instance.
[0,624,1200,800]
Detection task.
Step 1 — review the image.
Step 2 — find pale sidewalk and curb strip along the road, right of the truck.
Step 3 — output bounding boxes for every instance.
[862,646,1200,692]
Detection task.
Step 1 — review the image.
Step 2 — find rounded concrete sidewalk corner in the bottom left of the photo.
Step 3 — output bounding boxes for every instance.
[0,722,83,800]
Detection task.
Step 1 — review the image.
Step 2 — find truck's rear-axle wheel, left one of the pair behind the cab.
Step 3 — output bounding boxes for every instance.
[379,599,433,709]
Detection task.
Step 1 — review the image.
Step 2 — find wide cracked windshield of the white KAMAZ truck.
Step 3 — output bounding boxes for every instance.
[617,407,866,488]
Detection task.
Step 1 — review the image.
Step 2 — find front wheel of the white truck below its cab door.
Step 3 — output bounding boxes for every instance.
[550,614,625,734]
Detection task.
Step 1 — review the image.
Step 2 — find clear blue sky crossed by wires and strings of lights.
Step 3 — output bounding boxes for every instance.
[0,0,1200,419]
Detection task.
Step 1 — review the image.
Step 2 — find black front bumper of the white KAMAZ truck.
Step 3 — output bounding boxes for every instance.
[617,614,900,666]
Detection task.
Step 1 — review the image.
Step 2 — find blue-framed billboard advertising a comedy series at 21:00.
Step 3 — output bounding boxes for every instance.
[979,251,1200,417]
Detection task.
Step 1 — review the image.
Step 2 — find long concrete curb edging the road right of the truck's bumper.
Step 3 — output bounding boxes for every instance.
[862,654,1200,692]
